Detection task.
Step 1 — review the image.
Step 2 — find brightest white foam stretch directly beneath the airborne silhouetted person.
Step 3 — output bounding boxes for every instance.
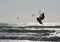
[20,22,60,26]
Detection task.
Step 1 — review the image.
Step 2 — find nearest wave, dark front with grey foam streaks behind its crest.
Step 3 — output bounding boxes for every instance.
[0,33,60,41]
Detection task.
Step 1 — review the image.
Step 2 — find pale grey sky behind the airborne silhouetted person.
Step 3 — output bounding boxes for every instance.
[0,0,60,23]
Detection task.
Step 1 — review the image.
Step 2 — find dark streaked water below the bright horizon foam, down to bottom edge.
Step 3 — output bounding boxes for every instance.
[0,23,60,42]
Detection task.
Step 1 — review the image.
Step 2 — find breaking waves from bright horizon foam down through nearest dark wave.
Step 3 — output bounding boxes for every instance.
[0,23,60,41]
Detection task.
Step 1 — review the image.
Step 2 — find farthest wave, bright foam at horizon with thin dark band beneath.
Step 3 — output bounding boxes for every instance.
[0,22,60,28]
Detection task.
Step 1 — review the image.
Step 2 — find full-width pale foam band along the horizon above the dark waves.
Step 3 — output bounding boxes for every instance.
[0,22,60,26]
